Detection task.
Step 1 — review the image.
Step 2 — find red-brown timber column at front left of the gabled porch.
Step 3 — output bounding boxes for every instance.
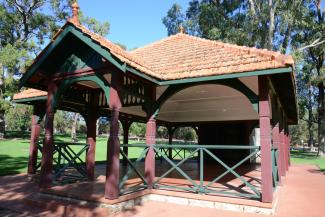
[39,80,58,188]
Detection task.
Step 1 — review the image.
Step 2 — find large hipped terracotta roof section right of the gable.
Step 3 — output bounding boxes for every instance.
[130,33,294,80]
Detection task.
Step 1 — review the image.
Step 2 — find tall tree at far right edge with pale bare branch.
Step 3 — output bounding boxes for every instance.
[293,0,325,156]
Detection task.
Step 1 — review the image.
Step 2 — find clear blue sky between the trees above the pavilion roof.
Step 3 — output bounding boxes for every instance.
[78,0,190,49]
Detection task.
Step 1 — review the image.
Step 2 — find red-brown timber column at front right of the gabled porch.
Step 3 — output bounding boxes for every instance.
[105,71,123,199]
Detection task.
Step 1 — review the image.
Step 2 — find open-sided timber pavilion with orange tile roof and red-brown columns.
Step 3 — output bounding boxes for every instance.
[14,1,297,205]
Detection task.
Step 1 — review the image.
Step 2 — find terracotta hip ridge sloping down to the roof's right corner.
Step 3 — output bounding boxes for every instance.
[178,34,294,65]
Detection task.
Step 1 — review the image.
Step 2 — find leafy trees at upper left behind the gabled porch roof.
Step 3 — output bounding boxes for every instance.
[0,0,109,138]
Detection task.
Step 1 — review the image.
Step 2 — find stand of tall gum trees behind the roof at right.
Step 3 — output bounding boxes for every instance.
[163,0,325,153]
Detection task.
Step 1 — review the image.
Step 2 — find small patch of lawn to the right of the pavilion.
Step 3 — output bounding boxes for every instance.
[291,150,325,172]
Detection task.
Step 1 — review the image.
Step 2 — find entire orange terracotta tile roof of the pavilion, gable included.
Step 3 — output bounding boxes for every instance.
[14,20,294,99]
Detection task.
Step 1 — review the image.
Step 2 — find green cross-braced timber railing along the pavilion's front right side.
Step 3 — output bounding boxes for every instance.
[119,144,262,198]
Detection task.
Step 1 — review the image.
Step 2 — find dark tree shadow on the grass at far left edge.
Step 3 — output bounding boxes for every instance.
[0,154,28,176]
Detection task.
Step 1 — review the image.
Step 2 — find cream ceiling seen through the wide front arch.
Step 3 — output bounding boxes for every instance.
[157,84,258,122]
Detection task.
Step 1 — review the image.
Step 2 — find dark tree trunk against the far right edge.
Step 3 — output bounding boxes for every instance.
[318,82,325,156]
